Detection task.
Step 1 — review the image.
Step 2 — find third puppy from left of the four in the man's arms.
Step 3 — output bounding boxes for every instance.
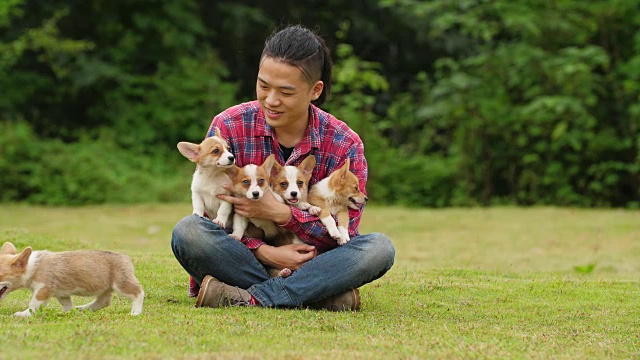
[269,155,321,277]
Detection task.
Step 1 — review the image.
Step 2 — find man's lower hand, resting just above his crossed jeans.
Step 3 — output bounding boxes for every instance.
[253,244,317,271]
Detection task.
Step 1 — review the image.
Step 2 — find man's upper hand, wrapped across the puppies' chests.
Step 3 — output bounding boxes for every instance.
[218,185,291,225]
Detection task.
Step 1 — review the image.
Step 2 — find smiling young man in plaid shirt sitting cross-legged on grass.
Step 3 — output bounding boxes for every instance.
[171,26,395,310]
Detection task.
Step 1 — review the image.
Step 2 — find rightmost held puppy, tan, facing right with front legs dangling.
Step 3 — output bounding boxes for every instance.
[309,159,369,245]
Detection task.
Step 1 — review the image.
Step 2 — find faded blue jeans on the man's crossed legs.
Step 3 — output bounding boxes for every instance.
[171,215,395,307]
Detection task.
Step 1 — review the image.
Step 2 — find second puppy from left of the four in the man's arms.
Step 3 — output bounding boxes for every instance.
[225,154,278,240]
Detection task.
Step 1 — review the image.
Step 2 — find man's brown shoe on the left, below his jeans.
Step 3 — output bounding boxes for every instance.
[196,275,251,307]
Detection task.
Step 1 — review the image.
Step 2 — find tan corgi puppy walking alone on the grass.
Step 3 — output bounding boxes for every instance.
[0,242,144,317]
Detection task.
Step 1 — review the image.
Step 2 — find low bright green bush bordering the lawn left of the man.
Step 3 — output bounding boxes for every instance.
[0,122,193,205]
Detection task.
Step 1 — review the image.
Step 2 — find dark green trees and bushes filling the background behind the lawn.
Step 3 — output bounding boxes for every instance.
[0,0,640,208]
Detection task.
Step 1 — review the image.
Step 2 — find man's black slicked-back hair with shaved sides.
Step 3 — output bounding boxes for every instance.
[260,25,333,106]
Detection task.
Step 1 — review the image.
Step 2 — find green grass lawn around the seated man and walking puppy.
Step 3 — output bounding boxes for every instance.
[0,204,640,359]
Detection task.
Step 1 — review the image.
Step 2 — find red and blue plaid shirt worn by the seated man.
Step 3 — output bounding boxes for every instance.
[207,101,367,251]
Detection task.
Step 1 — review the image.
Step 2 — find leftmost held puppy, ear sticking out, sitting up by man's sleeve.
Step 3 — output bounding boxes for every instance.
[178,128,235,228]
